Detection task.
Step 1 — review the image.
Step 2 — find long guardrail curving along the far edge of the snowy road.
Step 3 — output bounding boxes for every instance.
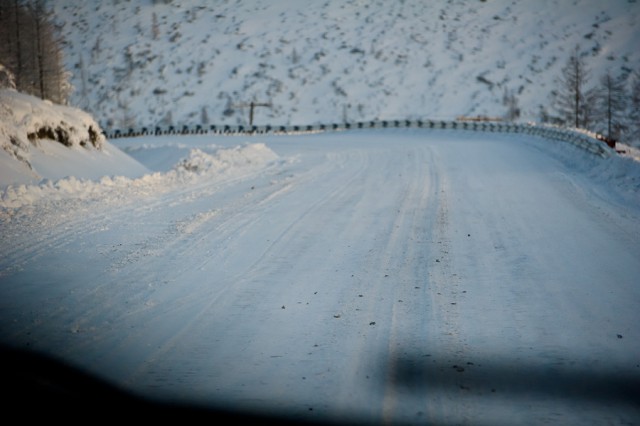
[103,120,615,158]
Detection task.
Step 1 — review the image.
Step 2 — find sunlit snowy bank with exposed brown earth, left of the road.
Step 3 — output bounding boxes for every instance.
[0,89,148,188]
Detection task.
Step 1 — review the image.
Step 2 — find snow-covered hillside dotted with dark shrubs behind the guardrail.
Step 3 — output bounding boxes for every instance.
[51,0,640,130]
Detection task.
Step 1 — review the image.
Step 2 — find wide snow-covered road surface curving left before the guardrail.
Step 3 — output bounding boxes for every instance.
[0,130,640,425]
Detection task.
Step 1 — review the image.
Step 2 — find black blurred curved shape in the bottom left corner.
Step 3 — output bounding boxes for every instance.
[0,347,328,425]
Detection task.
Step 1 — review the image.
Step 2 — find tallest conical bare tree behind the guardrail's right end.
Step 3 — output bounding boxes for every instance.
[554,47,594,128]
